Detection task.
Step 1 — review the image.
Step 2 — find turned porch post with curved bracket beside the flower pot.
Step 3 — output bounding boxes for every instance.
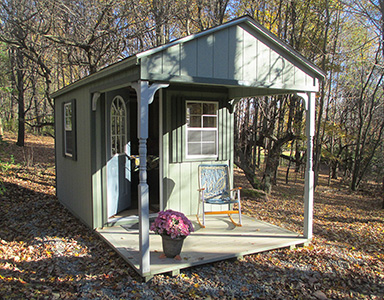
[132,80,169,275]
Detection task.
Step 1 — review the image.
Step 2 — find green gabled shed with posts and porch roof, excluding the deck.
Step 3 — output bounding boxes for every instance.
[53,16,325,276]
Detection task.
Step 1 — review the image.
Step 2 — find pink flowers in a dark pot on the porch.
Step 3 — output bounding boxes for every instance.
[150,209,194,258]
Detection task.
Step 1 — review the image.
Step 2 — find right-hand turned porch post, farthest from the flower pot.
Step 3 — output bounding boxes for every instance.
[297,92,316,239]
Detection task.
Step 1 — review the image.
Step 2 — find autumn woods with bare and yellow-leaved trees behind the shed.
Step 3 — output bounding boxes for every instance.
[0,0,384,191]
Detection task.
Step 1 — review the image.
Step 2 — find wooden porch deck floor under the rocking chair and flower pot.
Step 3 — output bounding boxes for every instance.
[97,216,308,279]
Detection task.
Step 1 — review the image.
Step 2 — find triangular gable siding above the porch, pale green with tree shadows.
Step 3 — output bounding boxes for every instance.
[141,22,318,90]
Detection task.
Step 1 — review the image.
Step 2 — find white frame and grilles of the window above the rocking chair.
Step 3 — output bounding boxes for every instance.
[185,100,219,159]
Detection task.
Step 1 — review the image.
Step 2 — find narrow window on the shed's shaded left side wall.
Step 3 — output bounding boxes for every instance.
[63,100,76,160]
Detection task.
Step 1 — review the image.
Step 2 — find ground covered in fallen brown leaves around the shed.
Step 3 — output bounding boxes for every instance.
[0,134,384,299]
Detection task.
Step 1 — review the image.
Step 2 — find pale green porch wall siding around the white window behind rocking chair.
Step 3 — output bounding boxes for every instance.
[163,90,233,215]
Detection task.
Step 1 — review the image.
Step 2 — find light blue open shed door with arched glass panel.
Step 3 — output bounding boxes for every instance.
[106,93,131,218]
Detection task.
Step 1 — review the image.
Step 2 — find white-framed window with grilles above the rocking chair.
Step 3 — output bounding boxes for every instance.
[186,101,218,158]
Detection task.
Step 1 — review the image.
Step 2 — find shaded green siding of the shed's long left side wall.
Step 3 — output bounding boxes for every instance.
[54,67,138,228]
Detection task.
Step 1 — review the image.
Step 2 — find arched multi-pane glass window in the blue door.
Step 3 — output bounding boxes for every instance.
[111,96,127,155]
